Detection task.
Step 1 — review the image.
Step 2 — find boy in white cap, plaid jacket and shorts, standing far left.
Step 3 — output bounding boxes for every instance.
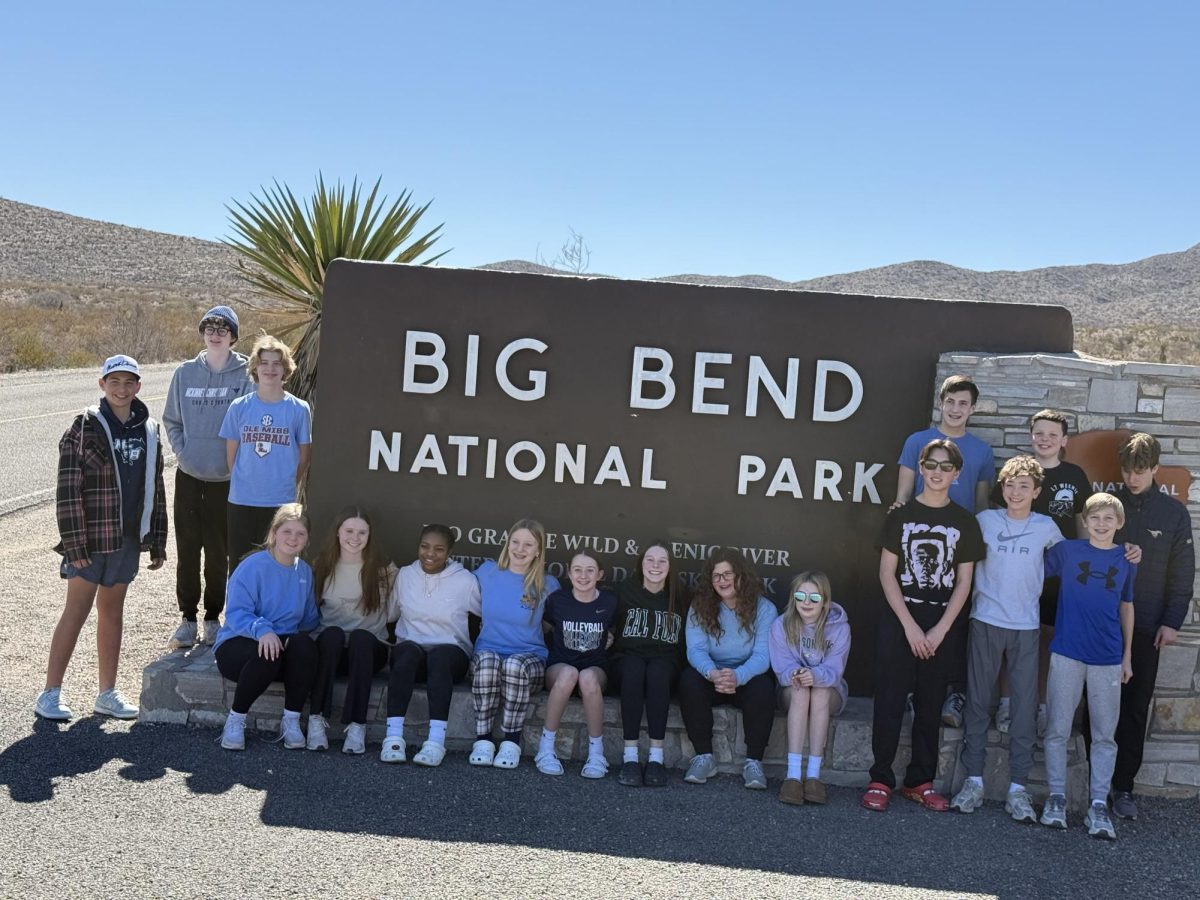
[35,354,167,719]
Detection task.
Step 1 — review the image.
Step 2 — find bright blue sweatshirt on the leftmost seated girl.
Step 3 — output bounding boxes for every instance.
[212,550,320,652]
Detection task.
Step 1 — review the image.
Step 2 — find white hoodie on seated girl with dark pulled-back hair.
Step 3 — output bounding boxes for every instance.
[391,559,484,656]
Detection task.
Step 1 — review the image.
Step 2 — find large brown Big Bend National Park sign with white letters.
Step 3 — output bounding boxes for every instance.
[308,260,1072,694]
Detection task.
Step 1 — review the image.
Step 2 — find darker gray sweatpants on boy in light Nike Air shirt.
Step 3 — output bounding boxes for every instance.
[962,619,1036,785]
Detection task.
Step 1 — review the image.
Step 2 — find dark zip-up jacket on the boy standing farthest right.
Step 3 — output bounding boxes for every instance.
[1116,481,1196,635]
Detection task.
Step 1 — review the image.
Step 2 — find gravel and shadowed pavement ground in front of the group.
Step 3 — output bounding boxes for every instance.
[0,473,1200,899]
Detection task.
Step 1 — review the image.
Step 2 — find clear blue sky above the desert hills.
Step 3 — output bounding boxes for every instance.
[0,0,1200,280]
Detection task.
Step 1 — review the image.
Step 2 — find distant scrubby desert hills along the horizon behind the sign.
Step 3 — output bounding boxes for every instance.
[0,198,1200,326]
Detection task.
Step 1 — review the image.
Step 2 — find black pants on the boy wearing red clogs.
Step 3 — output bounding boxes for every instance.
[871,604,958,787]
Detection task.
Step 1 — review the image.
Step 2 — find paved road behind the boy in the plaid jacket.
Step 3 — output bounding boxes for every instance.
[0,362,178,515]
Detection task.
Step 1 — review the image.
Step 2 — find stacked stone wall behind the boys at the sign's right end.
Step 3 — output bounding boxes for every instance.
[932,352,1200,796]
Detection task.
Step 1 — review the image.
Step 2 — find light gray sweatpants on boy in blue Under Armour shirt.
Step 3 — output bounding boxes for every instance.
[1045,653,1121,803]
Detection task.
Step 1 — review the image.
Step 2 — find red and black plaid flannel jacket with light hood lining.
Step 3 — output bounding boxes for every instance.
[54,408,167,564]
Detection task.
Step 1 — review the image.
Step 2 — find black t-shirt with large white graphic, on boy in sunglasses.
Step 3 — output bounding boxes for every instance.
[878,497,988,606]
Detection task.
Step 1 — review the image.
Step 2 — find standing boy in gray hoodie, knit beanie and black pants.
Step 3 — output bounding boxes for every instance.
[162,306,253,647]
